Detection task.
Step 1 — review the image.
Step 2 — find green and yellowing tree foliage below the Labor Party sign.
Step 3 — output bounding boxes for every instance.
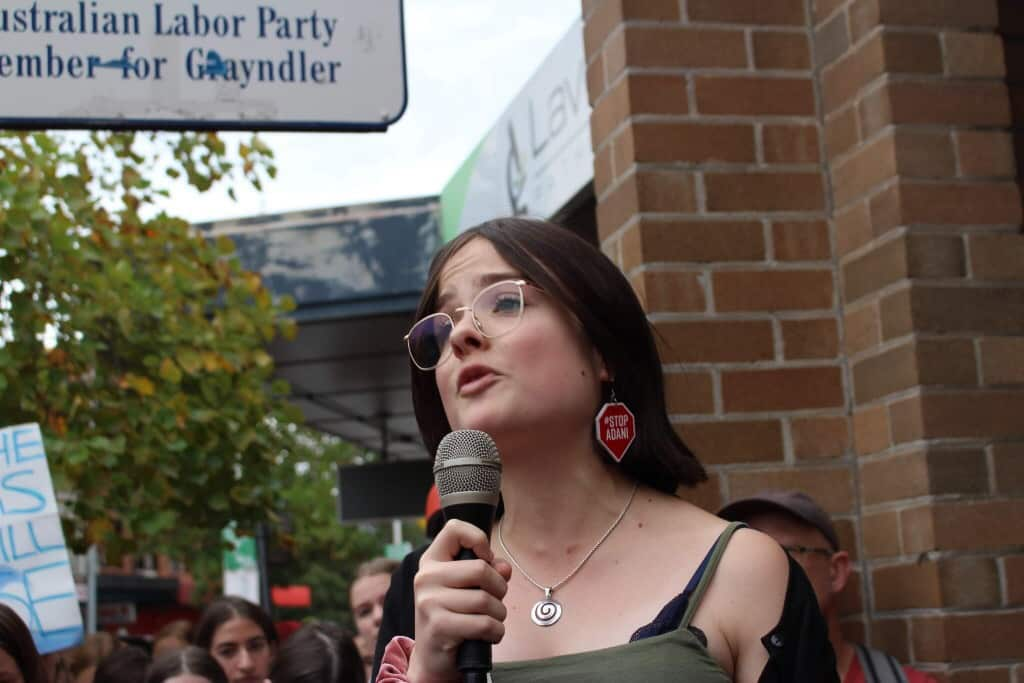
[0,132,296,557]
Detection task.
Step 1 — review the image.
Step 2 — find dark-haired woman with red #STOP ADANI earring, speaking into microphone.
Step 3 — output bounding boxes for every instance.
[376,218,836,683]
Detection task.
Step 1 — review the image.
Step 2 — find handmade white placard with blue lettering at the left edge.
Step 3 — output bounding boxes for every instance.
[0,424,83,653]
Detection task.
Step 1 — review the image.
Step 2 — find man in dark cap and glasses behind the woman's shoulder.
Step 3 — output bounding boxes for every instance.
[718,490,936,683]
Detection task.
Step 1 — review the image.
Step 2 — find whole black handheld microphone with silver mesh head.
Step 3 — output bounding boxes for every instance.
[434,429,502,683]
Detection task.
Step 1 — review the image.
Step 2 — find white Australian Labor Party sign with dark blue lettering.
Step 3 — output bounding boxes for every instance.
[0,0,407,130]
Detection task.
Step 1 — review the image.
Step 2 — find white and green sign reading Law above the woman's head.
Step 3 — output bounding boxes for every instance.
[441,19,594,240]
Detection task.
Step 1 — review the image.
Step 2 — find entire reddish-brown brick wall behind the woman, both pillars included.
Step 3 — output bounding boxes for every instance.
[583,0,1024,683]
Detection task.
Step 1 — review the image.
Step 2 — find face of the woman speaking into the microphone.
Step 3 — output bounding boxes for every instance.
[434,238,607,446]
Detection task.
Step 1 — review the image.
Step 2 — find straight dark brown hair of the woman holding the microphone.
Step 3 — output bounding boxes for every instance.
[410,218,708,493]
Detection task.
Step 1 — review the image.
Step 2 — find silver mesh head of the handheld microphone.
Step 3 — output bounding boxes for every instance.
[434,429,502,505]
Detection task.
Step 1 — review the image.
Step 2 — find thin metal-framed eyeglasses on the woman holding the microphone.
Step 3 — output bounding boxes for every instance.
[406,280,527,372]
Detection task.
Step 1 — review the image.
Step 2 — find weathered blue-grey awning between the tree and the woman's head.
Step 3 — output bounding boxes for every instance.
[198,197,439,460]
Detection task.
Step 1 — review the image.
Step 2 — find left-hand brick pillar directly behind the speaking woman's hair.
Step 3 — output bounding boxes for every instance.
[584,0,860,612]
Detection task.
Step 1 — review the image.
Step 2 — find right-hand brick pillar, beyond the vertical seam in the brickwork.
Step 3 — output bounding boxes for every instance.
[815,0,1024,681]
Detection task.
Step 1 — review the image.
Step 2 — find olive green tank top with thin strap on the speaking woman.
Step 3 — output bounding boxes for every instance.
[492,522,743,683]
